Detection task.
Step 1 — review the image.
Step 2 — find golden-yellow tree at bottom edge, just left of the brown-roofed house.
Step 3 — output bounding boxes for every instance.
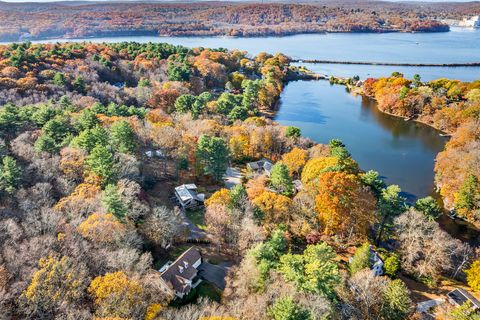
[88,271,144,318]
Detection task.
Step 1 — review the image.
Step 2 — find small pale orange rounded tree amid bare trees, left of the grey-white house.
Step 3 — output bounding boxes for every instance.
[78,213,127,244]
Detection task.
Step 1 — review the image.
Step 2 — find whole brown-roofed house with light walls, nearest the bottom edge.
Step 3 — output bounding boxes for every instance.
[159,247,202,299]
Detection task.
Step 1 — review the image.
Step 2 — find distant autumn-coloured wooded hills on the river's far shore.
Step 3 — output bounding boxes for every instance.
[0,1,470,41]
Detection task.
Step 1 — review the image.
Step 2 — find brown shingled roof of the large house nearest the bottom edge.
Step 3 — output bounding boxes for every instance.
[160,247,201,293]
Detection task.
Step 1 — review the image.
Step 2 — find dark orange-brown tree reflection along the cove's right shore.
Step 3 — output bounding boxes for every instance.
[361,97,447,153]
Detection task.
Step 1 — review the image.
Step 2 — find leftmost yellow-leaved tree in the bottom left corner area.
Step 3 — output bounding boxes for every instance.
[22,255,87,314]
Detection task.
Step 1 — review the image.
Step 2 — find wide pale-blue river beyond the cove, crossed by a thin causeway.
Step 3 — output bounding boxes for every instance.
[12,28,480,81]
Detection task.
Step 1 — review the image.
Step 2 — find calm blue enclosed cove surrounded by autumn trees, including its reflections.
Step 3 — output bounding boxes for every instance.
[275,81,447,201]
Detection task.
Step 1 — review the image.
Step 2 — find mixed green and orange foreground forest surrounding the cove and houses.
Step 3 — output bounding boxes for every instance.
[0,42,480,320]
